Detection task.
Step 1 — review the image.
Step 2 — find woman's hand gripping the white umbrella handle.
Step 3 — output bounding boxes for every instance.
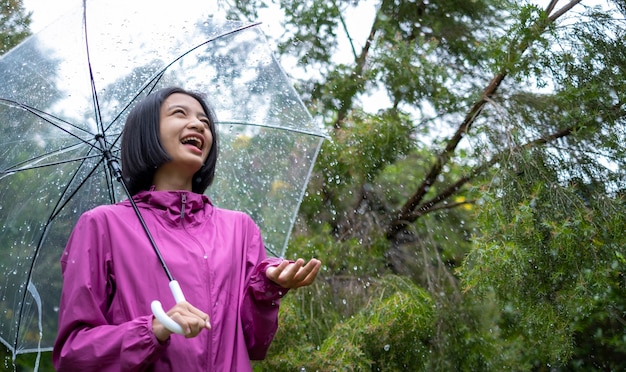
[152,301,211,342]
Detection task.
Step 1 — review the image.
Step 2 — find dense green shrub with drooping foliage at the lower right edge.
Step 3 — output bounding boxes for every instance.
[463,151,626,370]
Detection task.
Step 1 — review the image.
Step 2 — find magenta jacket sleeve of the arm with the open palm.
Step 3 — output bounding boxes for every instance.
[241,217,288,360]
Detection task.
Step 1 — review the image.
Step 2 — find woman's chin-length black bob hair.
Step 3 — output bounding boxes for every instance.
[121,87,218,195]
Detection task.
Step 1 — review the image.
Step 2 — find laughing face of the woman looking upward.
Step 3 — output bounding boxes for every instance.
[159,93,213,175]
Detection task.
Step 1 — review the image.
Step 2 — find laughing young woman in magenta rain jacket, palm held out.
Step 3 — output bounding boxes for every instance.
[53,88,321,372]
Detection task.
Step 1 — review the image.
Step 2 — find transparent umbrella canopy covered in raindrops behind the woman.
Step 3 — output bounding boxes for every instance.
[0,0,324,355]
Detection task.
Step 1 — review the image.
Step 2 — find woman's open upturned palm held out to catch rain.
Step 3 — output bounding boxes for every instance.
[265,258,322,289]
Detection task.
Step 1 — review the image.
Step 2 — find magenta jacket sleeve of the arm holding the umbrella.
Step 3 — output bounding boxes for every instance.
[52,212,167,371]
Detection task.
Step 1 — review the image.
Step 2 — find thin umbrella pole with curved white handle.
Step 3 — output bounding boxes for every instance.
[96,134,186,334]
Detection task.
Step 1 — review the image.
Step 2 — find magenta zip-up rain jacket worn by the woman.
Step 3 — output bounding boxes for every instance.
[52,191,287,372]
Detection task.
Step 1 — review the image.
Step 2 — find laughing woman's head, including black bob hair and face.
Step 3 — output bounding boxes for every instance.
[122,88,218,195]
